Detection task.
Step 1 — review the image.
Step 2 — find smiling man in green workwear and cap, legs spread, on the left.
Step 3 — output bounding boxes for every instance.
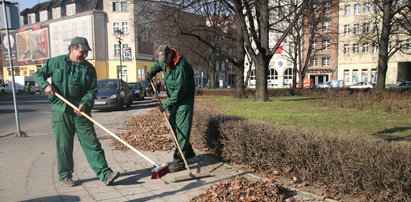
[34,37,120,186]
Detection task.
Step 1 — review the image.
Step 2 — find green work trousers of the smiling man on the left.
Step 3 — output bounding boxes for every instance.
[51,109,113,181]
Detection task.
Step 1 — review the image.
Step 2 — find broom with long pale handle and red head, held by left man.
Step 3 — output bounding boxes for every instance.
[55,93,170,179]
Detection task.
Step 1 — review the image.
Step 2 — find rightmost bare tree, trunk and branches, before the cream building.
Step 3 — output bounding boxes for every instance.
[358,0,411,89]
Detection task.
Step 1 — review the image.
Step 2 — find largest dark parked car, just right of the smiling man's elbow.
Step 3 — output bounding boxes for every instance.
[93,79,133,110]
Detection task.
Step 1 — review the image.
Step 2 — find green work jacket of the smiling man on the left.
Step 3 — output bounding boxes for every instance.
[34,55,97,114]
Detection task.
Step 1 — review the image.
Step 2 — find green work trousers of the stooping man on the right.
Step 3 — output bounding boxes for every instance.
[169,99,195,166]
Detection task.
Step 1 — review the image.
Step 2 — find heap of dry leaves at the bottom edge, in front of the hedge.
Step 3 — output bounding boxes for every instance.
[191,177,297,202]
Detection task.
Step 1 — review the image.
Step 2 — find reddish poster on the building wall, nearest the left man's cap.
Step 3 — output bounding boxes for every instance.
[30,29,50,60]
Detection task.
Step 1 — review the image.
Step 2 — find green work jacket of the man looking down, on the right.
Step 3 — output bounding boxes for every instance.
[148,56,195,110]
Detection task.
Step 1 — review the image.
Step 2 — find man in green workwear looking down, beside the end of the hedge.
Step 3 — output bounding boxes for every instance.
[146,45,195,172]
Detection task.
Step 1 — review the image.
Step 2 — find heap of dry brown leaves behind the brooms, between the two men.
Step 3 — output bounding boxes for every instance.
[113,108,174,151]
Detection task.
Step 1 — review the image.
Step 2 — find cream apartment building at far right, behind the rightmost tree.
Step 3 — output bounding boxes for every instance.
[338,0,411,85]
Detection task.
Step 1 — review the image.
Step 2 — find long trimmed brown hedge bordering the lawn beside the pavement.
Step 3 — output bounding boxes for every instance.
[192,106,411,201]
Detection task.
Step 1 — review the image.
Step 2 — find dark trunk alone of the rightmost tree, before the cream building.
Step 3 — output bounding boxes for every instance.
[377,0,392,89]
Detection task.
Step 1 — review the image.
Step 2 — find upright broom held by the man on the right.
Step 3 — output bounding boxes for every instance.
[150,80,211,183]
